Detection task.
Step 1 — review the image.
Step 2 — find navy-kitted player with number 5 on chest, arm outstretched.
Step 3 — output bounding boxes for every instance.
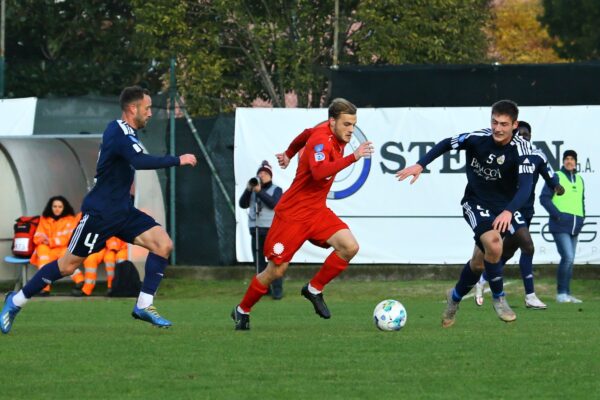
[396,100,533,328]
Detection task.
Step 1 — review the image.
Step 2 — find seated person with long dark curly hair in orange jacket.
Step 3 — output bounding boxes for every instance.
[30,196,83,296]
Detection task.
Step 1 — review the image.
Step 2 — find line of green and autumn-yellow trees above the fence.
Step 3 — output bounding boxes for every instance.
[5,0,600,115]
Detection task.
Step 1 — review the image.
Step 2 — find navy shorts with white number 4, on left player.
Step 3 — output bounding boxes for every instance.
[69,207,160,257]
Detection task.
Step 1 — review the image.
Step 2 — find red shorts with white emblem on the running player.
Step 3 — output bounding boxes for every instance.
[263,208,348,265]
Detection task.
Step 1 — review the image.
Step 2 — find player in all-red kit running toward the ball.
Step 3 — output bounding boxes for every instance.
[231,99,373,330]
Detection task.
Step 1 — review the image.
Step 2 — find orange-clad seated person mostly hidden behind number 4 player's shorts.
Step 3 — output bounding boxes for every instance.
[73,236,127,296]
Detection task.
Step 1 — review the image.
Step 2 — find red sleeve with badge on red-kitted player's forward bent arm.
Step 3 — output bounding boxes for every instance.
[304,135,356,180]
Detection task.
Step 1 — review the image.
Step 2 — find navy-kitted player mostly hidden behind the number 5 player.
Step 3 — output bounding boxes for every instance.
[475,121,565,310]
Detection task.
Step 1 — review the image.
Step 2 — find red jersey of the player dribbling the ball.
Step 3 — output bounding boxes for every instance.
[275,122,356,221]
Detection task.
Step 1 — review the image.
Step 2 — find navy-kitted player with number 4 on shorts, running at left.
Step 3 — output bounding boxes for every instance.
[0,86,196,333]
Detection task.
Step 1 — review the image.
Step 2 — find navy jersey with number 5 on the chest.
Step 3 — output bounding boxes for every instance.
[418,128,534,215]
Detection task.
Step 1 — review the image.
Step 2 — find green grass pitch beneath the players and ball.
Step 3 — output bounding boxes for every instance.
[0,279,600,399]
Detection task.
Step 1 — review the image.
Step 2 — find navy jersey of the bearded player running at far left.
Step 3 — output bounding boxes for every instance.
[81,120,179,215]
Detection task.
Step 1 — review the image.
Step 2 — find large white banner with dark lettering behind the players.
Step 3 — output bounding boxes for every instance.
[234,106,600,264]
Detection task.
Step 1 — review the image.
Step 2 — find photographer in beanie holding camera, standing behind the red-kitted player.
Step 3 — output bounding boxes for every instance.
[239,160,283,300]
